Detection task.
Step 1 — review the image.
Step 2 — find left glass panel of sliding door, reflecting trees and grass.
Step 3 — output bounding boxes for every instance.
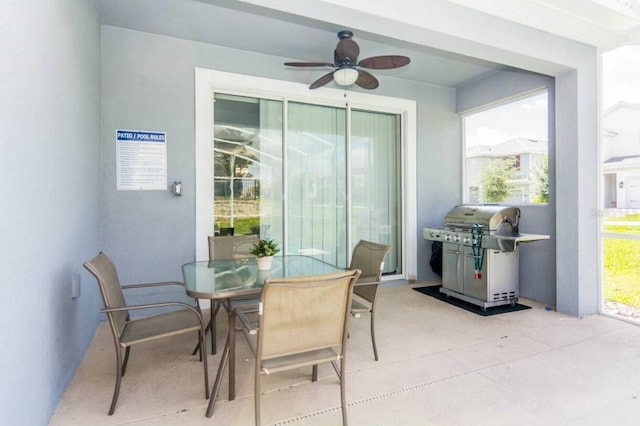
[213,93,282,241]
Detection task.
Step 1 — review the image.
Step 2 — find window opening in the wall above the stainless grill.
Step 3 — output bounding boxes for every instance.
[462,91,549,204]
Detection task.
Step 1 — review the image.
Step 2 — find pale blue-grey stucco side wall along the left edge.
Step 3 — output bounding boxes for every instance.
[0,0,101,425]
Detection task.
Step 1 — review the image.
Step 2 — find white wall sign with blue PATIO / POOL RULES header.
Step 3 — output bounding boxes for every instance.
[116,130,167,191]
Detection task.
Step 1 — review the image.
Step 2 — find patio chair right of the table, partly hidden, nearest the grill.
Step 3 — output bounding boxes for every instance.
[349,240,391,361]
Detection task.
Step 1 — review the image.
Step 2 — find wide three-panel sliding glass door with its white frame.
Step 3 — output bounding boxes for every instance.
[196,70,415,278]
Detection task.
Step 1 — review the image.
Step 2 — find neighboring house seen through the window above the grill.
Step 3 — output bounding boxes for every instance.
[465,138,548,204]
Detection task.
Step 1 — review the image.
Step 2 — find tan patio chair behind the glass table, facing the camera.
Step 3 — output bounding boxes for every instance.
[202,235,260,354]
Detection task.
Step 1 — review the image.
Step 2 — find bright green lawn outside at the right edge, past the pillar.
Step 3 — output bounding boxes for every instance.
[604,218,640,308]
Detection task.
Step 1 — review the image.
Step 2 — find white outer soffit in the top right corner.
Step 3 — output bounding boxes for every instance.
[446,0,640,48]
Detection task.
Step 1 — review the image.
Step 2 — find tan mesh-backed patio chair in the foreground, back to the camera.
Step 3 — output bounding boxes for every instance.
[233,270,360,425]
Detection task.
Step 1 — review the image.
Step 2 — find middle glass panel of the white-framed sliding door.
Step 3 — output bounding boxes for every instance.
[285,102,347,266]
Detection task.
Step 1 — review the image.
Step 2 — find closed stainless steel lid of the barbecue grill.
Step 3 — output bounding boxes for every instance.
[445,204,520,231]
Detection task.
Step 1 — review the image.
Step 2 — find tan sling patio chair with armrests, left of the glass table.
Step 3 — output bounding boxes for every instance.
[84,252,209,415]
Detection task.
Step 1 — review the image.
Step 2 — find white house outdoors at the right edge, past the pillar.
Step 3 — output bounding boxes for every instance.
[602,102,640,209]
